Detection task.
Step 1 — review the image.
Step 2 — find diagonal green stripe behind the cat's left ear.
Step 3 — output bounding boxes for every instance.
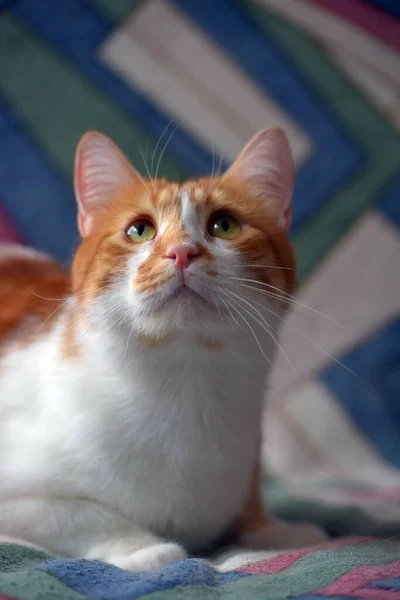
[0,14,188,180]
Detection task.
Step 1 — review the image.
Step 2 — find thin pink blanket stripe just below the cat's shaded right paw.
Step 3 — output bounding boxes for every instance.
[236,537,367,575]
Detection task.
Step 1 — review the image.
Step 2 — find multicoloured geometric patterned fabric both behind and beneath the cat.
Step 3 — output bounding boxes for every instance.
[0,0,400,599]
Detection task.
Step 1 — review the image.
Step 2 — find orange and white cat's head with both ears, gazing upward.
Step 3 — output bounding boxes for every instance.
[73,128,295,338]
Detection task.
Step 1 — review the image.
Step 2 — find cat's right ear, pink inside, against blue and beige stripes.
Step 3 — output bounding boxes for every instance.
[224,127,294,231]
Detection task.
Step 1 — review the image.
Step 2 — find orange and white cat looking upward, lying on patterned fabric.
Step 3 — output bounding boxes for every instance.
[0,128,324,570]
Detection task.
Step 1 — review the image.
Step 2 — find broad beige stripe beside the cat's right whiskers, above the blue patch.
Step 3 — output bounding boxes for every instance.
[271,212,400,391]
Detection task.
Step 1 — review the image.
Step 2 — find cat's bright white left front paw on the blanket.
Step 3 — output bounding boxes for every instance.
[109,542,187,571]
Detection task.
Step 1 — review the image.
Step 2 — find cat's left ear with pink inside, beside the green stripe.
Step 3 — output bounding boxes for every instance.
[74,131,139,237]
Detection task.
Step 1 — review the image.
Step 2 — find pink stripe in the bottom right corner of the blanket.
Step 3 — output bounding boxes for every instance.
[315,560,400,598]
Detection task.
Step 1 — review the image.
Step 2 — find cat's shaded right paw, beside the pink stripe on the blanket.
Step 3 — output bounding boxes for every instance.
[240,521,328,550]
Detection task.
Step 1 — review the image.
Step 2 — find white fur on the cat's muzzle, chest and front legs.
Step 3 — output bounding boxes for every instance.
[0,197,318,570]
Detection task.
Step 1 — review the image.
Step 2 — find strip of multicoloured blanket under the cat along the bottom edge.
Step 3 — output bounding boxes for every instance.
[0,538,400,600]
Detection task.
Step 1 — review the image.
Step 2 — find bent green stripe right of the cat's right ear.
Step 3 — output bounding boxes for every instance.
[241,0,400,281]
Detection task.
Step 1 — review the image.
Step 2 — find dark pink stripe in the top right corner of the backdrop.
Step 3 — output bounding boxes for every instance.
[312,0,400,51]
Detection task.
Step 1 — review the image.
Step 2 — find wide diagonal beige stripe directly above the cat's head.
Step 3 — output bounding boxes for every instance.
[100,0,312,165]
